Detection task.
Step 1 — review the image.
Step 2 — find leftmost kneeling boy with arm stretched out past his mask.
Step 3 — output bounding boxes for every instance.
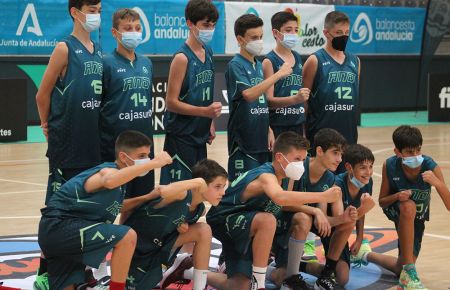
[38,131,172,290]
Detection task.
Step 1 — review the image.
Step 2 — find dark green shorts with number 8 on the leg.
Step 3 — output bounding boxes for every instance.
[228,147,271,181]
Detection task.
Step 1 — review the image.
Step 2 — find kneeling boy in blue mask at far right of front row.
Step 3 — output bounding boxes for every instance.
[356,125,450,289]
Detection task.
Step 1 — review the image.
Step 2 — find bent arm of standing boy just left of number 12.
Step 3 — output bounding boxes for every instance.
[263,58,309,108]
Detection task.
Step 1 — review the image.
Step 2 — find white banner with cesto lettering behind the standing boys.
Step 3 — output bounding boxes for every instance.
[225,2,334,54]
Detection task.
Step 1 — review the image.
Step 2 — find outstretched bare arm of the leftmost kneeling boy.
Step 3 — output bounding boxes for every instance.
[84,151,172,192]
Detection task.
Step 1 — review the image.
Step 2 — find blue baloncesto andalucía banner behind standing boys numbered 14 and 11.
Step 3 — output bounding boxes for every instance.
[101,0,225,54]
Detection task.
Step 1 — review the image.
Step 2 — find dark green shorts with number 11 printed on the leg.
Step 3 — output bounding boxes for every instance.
[159,134,207,185]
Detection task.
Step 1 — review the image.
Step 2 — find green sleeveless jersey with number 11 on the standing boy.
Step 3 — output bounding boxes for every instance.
[164,43,214,145]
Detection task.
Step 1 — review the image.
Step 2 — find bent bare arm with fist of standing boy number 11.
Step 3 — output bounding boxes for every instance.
[166,53,222,119]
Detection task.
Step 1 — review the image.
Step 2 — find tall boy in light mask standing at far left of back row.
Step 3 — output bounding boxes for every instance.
[34,0,103,289]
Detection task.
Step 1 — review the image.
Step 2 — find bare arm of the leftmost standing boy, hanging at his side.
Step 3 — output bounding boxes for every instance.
[36,42,69,137]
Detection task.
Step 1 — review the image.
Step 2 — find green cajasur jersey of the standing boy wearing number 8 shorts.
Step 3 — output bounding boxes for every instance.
[225,54,269,154]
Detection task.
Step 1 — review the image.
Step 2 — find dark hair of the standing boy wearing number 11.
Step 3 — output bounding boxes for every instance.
[184,0,219,24]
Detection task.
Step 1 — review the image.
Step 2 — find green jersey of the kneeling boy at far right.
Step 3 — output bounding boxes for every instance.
[386,155,437,220]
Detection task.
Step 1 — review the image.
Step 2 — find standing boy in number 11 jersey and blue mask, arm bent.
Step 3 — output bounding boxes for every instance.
[160,0,222,184]
